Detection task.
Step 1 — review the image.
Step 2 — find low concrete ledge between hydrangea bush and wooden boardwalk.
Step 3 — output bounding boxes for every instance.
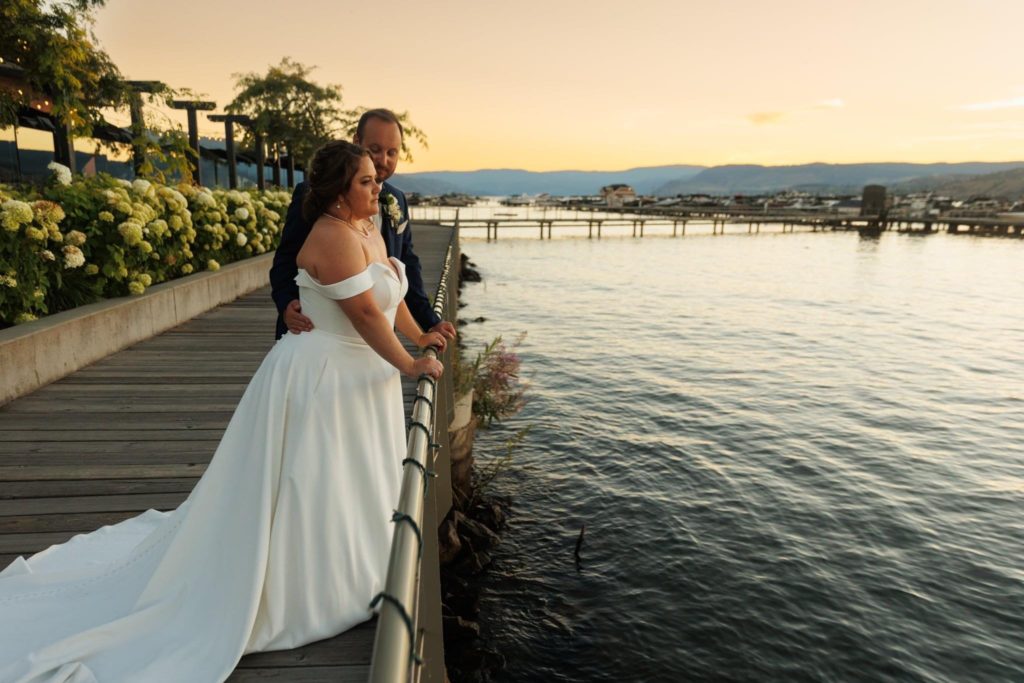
[0,252,273,405]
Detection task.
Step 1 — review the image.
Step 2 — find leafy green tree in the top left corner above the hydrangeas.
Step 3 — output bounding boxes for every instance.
[0,0,128,135]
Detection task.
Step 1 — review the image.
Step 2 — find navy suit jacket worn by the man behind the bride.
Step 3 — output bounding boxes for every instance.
[270,181,440,339]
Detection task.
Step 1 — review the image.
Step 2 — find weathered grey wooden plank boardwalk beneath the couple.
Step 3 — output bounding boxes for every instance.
[0,225,454,683]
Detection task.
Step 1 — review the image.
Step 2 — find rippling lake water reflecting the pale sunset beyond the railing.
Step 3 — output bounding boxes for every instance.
[460,231,1024,681]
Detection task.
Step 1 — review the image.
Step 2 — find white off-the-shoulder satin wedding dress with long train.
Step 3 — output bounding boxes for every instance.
[0,258,408,683]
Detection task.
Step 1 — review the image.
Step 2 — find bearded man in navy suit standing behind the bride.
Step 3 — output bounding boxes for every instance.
[270,109,455,339]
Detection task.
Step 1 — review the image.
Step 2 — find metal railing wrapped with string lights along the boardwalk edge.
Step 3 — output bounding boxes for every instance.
[370,240,458,683]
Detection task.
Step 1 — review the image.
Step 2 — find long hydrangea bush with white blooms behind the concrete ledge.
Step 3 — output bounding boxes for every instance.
[0,175,291,327]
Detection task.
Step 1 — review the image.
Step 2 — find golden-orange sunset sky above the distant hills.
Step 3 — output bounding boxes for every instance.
[51,0,1024,172]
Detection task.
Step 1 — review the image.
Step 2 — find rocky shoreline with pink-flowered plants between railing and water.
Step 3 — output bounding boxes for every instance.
[438,254,528,683]
